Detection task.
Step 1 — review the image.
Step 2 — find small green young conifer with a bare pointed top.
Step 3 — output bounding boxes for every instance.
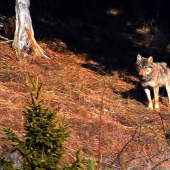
[0,75,84,170]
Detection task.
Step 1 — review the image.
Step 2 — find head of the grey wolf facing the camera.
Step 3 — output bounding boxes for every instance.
[136,54,153,80]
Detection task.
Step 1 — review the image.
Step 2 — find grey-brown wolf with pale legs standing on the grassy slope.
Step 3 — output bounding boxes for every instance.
[136,54,170,111]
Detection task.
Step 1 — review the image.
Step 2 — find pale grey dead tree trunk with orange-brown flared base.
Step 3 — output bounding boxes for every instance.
[12,0,49,58]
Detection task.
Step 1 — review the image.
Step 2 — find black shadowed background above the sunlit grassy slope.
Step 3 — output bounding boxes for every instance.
[0,0,170,74]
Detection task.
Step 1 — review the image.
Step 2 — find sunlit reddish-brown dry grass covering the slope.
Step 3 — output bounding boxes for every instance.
[0,39,169,169]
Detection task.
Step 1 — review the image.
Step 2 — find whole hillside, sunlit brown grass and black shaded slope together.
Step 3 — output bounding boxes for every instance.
[0,0,170,170]
